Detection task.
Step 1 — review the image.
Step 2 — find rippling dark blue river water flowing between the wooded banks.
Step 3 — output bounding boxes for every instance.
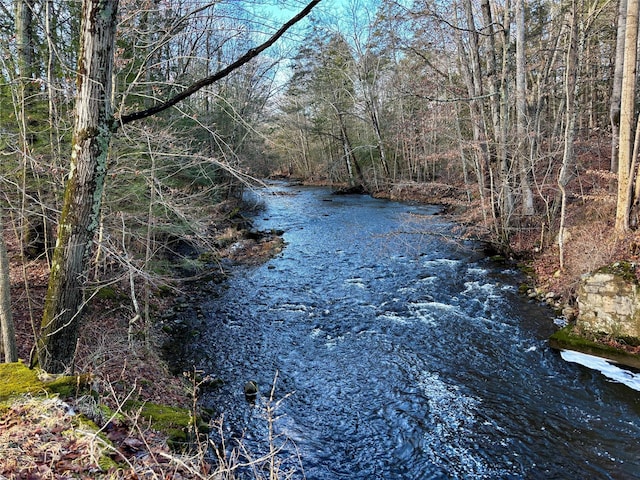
[179,185,640,480]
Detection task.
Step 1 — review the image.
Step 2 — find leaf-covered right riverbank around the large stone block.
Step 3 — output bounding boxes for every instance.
[374,178,640,368]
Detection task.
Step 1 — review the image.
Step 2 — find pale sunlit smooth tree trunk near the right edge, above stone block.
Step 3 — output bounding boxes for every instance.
[615,0,639,233]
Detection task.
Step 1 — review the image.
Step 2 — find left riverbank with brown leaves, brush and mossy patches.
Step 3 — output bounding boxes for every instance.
[0,195,282,478]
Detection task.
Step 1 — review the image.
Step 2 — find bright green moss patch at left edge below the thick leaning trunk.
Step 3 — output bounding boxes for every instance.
[0,362,87,400]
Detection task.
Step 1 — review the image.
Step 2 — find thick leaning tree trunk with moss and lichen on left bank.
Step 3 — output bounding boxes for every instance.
[34,0,118,373]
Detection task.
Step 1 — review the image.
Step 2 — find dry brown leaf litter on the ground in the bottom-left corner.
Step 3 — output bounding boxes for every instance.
[0,398,214,480]
